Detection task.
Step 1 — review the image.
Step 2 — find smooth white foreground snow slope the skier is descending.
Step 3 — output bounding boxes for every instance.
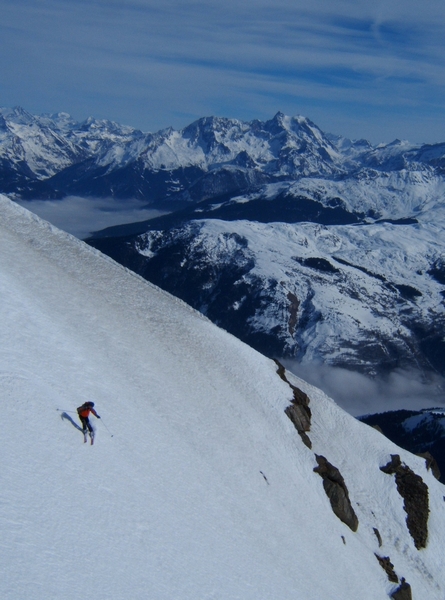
[0,196,445,600]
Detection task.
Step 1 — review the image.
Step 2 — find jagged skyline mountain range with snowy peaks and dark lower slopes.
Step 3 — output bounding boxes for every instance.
[0,108,445,203]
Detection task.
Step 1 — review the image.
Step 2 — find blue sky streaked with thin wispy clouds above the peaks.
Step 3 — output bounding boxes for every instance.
[0,0,445,143]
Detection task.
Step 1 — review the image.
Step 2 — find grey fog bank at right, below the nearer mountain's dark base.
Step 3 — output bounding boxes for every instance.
[281,360,445,417]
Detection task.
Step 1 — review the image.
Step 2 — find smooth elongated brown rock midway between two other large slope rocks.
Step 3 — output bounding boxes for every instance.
[314,455,358,531]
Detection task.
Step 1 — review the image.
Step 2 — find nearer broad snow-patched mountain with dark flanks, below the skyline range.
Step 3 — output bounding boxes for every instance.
[89,188,445,375]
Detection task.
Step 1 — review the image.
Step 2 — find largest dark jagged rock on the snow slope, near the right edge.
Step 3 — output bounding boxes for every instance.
[380,454,430,550]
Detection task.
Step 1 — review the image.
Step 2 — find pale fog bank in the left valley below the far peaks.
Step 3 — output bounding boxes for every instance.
[17,196,165,240]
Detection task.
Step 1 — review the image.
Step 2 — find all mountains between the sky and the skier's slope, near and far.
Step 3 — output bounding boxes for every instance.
[0,109,445,382]
